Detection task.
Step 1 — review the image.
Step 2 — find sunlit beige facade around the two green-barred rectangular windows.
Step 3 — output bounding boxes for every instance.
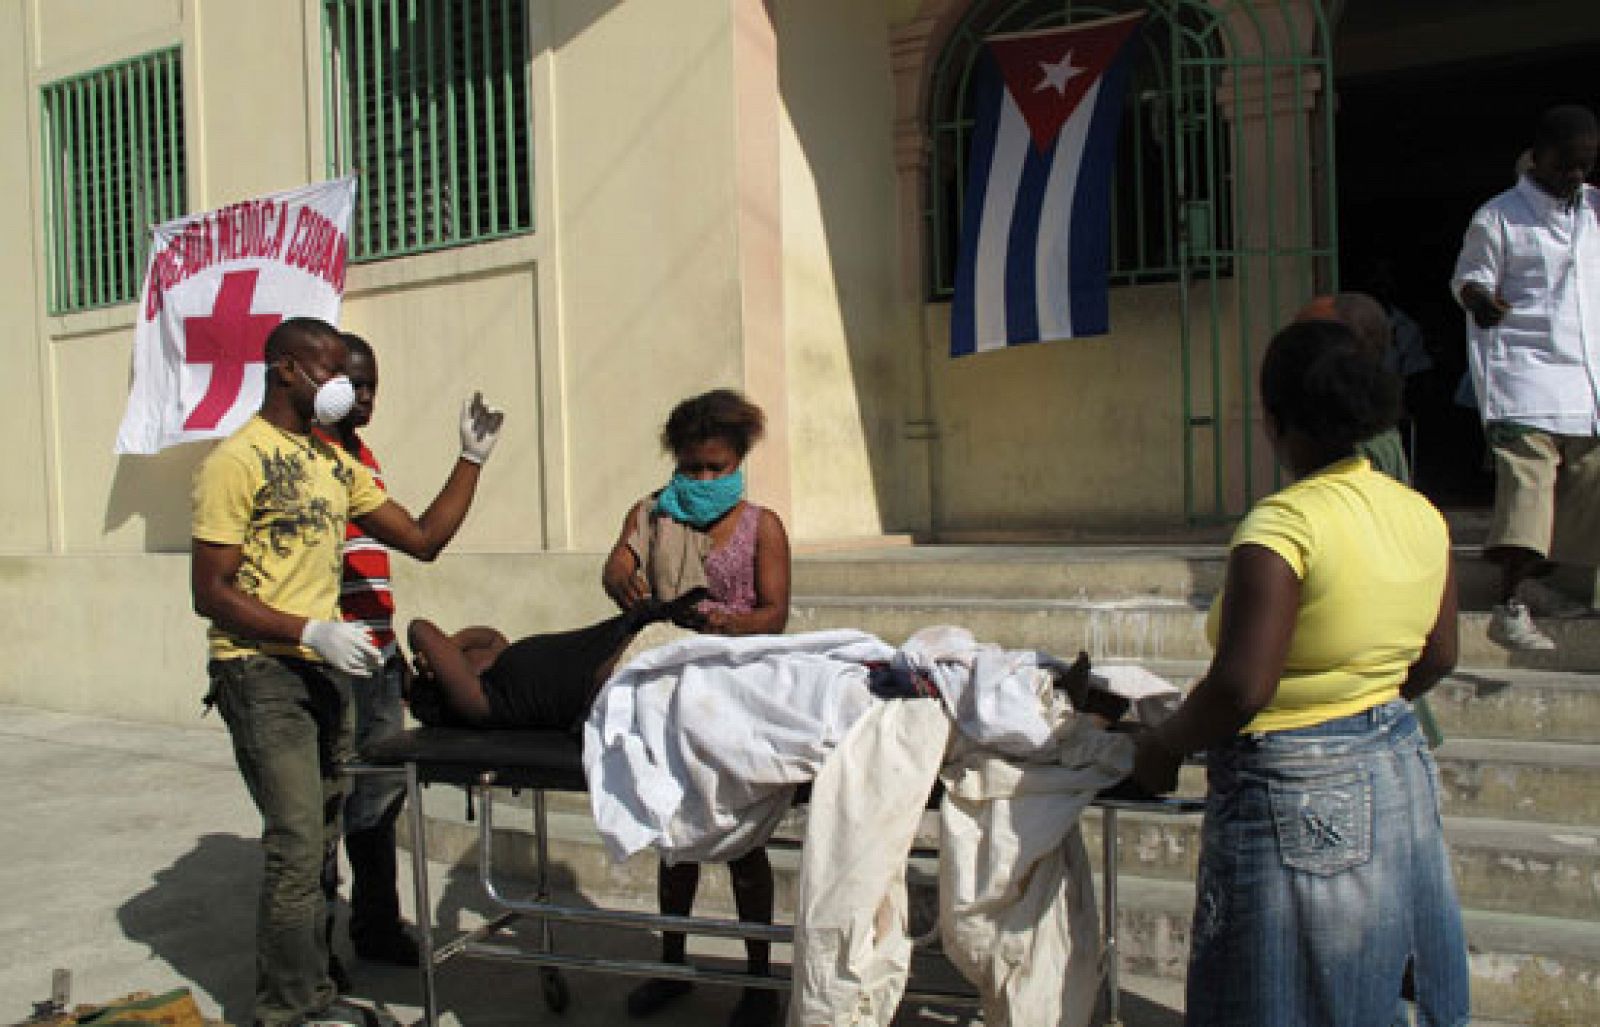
[0,0,761,721]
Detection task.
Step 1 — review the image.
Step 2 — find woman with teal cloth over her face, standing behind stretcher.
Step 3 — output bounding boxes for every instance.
[602,389,789,1025]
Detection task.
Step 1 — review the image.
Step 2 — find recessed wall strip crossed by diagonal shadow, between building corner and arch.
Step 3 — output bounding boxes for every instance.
[771,0,928,539]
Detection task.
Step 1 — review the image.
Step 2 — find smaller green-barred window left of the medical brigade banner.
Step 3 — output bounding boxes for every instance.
[40,46,187,314]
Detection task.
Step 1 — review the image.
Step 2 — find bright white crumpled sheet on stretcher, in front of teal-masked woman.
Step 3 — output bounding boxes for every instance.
[584,630,894,862]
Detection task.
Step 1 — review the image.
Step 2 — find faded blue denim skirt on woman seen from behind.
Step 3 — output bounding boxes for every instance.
[1186,699,1469,1027]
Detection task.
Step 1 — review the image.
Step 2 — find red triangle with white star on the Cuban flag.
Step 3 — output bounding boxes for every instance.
[986,11,1144,152]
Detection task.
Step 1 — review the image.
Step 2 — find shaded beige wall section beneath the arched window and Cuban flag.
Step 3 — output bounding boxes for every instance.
[925,285,1240,537]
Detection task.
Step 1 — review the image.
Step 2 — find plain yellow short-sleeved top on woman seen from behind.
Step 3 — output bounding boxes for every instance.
[1206,458,1450,733]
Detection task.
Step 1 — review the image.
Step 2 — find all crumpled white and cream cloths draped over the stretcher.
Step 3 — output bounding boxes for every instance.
[584,627,1178,1027]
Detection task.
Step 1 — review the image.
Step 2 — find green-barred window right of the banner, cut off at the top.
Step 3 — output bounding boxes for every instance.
[323,0,533,261]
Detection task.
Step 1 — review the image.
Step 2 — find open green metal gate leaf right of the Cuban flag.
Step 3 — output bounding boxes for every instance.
[1171,0,1338,521]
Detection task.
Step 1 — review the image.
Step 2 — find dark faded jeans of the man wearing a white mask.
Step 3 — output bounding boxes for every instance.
[210,656,355,1027]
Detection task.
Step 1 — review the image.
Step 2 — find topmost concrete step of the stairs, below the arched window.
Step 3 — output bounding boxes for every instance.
[792,544,1529,609]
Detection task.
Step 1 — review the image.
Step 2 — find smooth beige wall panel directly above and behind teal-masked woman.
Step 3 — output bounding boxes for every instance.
[549,0,744,550]
